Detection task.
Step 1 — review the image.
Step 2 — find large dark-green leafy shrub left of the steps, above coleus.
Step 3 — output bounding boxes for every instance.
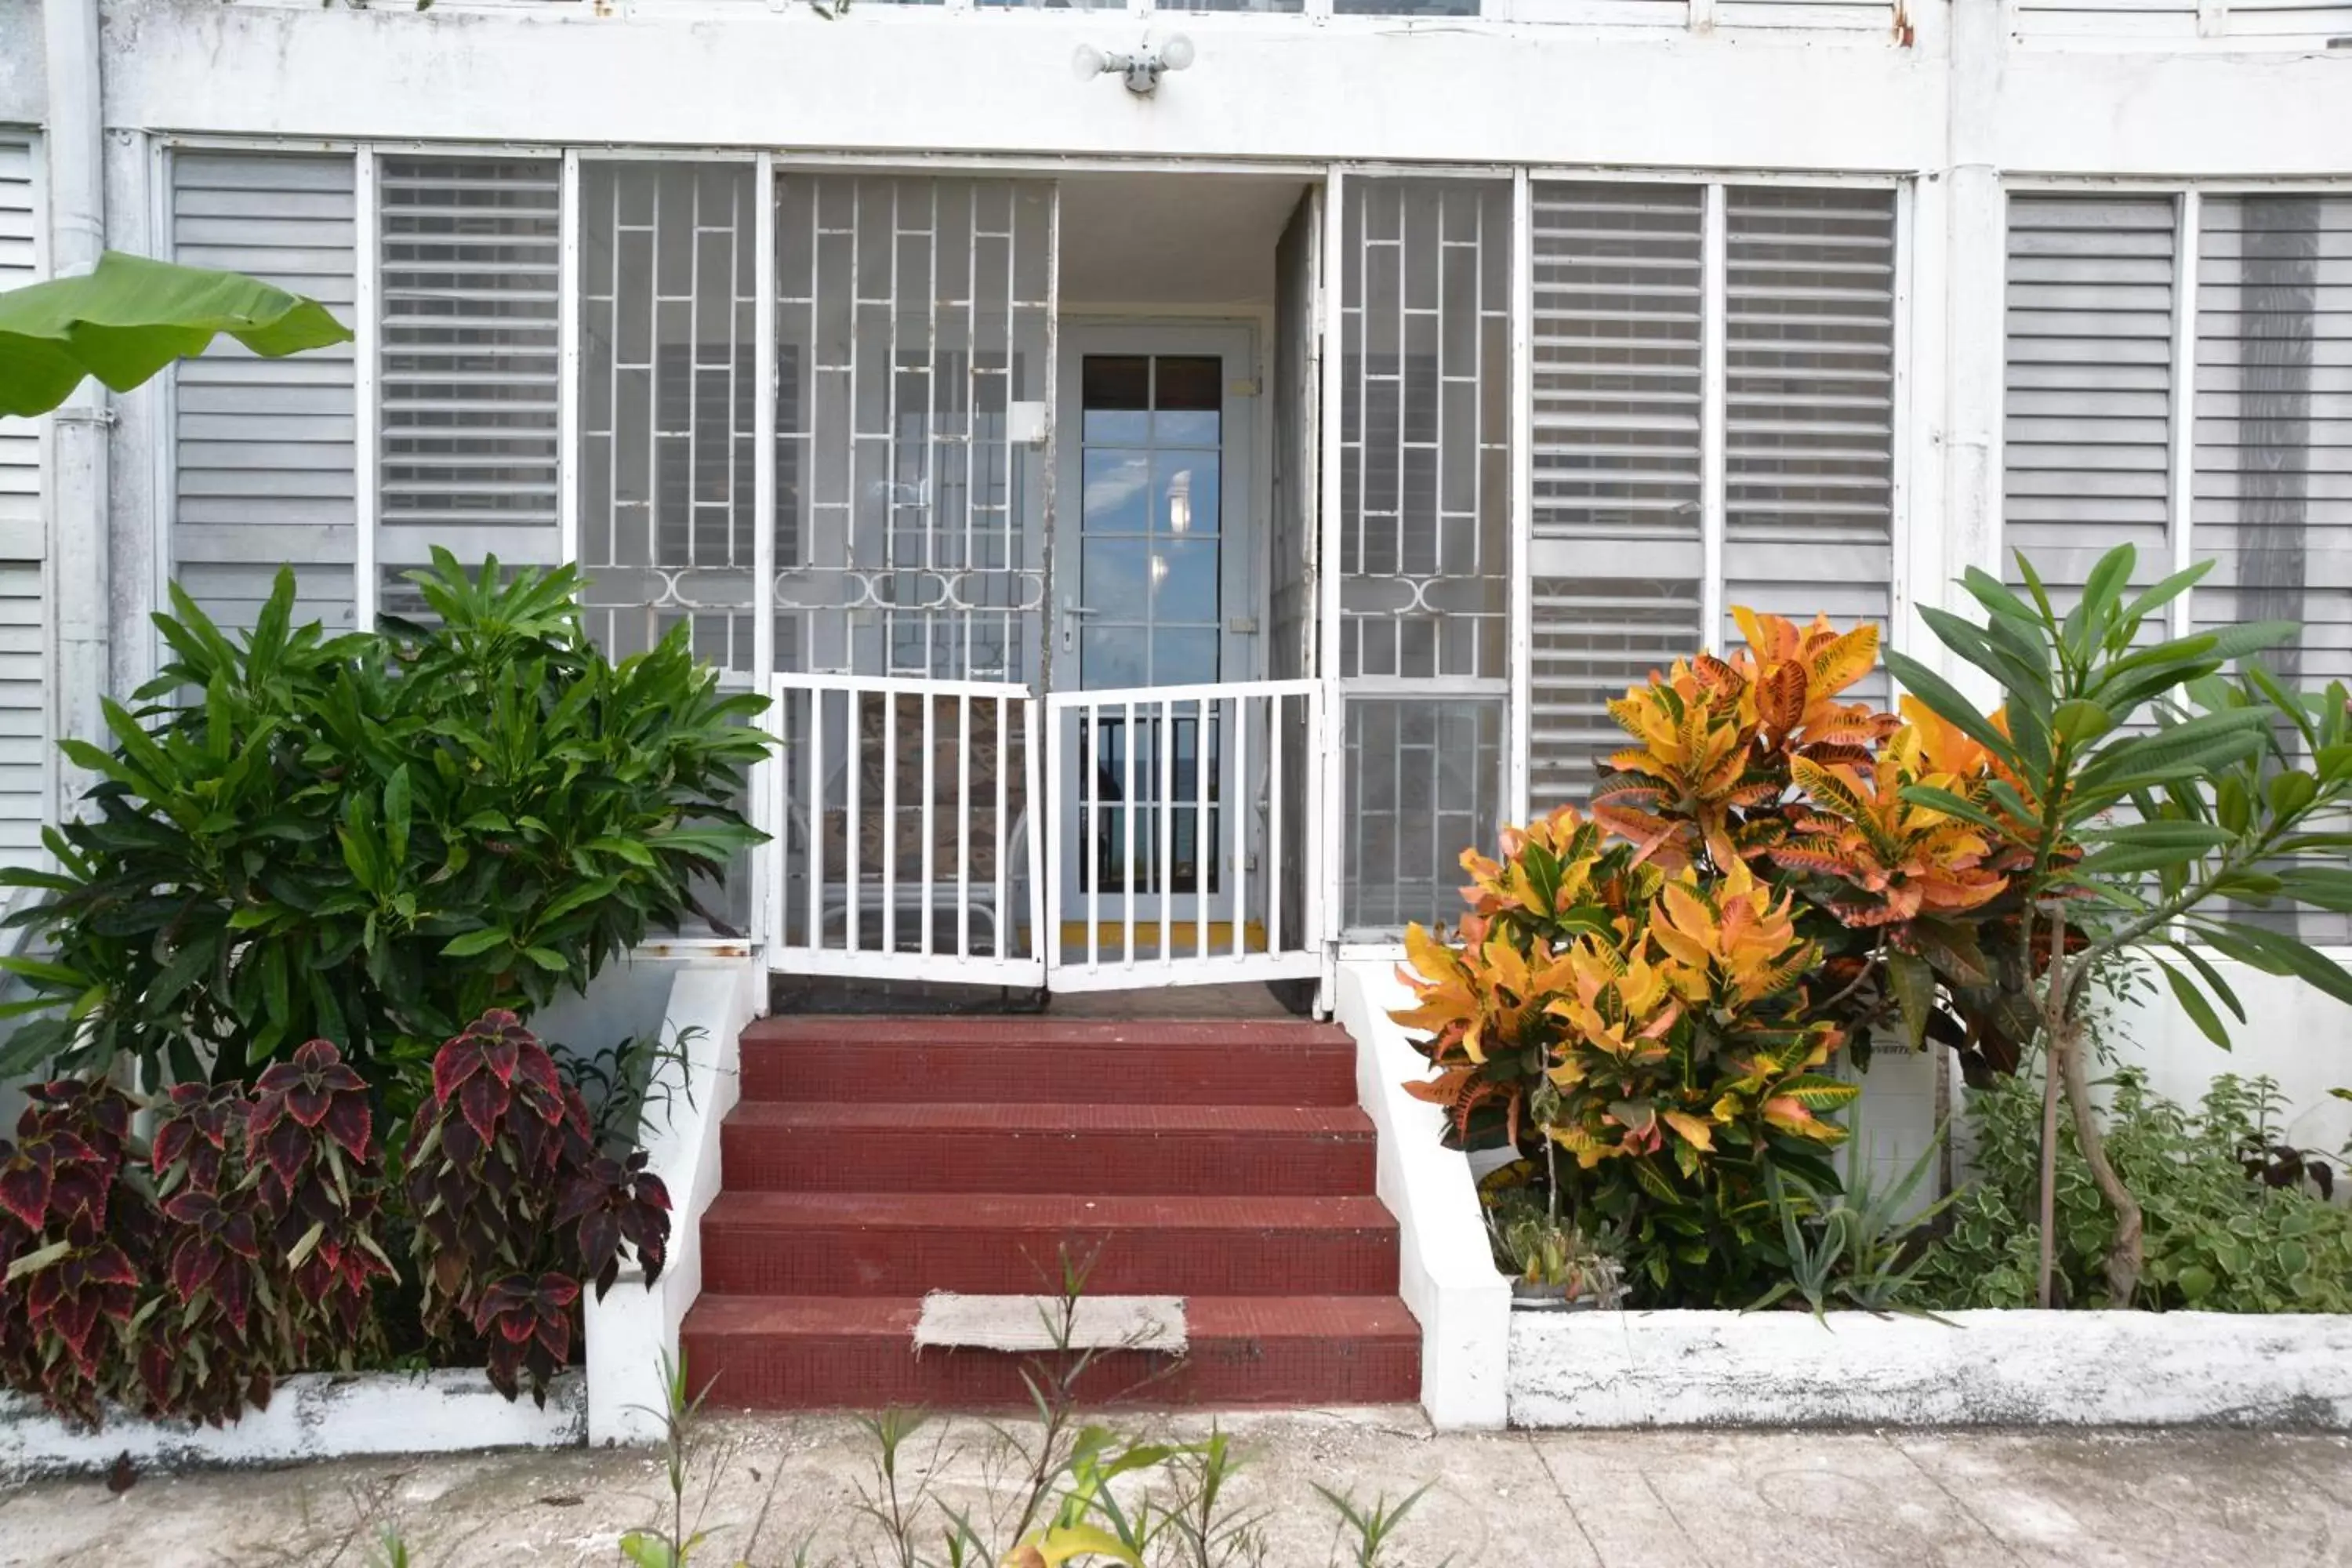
[0,550,767,1114]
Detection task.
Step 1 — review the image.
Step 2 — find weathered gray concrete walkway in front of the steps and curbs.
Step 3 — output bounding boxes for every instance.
[0,1410,2352,1568]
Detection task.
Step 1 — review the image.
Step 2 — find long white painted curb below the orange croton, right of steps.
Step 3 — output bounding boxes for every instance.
[1510,1312,2352,1432]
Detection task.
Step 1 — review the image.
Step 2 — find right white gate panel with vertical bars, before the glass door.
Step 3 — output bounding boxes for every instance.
[1044,680,1322,989]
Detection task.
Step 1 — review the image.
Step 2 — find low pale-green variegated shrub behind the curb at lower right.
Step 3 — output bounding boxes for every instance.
[1915,1069,2352,1312]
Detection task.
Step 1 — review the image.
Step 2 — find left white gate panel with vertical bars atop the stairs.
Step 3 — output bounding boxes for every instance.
[764,675,1044,985]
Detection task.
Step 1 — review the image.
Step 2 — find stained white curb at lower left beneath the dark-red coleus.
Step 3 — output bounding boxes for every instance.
[0,1368,588,1483]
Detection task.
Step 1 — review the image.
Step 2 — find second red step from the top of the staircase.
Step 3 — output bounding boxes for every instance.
[720,1100,1376,1196]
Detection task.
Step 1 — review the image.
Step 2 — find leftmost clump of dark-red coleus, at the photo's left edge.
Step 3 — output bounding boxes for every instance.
[0,1039,393,1425]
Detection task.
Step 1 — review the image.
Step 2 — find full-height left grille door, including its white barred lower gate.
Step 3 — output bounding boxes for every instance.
[767,172,1056,985]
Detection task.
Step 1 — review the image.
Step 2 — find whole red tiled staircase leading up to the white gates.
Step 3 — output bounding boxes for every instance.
[684,1018,1421,1410]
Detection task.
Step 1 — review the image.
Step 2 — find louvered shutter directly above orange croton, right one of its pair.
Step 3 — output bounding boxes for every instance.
[1722,186,1896,703]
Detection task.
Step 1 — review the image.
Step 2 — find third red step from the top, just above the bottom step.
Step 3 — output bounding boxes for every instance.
[703,1189,1397,1298]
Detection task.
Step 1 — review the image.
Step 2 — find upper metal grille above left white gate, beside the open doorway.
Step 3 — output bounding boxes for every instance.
[776,174,1054,684]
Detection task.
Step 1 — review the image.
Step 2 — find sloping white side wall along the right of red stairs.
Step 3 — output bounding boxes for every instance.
[1334,964,1512,1429]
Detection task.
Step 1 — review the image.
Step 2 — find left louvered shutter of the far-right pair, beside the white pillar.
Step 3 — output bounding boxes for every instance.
[2002,195,2176,593]
